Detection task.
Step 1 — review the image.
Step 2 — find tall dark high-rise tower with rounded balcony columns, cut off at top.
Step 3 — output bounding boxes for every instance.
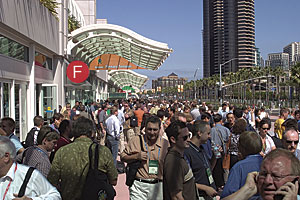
[203,0,255,77]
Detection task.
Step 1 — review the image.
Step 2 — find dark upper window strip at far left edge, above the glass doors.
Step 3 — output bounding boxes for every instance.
[0,35,29,62]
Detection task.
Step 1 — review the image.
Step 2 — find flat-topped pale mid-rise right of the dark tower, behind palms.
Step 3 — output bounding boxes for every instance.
[265,53,289,70]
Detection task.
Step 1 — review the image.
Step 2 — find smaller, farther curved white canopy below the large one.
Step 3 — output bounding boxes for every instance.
[108,70,148,91]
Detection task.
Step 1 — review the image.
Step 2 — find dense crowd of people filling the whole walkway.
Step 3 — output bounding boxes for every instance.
[0,99,300,200]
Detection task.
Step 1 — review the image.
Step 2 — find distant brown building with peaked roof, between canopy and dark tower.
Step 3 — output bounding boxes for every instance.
[152,73,187,92]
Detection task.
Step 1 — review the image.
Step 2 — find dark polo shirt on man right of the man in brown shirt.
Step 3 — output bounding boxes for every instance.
[184,142,216,197]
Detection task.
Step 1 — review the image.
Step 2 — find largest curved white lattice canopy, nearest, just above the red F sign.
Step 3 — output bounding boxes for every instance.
[67,24,173,70]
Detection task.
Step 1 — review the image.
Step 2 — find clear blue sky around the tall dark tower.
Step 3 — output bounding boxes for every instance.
[97,0,300,88]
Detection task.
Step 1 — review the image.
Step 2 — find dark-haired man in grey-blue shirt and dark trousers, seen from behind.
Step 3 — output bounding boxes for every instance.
[210,114,230,188]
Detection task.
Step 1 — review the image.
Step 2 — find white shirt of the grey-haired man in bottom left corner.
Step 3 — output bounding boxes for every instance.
[0,163,61,200]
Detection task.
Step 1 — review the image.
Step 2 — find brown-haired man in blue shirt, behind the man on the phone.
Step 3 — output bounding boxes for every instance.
[221,131,263,198]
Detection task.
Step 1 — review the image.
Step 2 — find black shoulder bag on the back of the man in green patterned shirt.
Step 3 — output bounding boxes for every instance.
[81,143,116,200]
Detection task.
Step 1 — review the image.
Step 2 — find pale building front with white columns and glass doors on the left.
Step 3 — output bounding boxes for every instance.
[0,0,107,141]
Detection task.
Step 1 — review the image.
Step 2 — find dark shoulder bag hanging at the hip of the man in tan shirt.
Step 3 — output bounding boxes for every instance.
[125,135,144,187]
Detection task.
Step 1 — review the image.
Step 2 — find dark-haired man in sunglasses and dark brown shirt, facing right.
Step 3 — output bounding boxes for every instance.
[163,120,198,200]
